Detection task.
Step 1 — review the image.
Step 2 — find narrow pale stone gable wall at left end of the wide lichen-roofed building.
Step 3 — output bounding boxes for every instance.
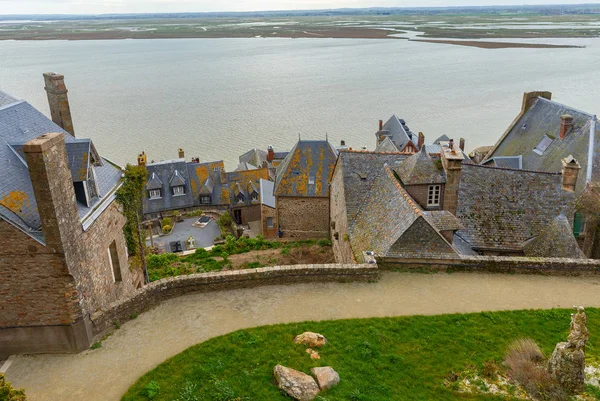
[330,163,355,263]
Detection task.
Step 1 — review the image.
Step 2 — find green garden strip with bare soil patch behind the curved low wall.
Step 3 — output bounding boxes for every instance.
[146,237,335,281]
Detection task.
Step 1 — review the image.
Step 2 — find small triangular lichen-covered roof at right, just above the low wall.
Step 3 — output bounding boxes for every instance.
[523,213,585,259]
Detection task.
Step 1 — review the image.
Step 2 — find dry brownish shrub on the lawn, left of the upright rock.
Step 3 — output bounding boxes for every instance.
[504,338,569,401]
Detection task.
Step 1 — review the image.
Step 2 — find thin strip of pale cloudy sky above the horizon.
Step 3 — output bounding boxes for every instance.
[0,0,583,14]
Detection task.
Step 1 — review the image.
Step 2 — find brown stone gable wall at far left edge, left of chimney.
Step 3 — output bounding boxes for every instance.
[0,220,81,328]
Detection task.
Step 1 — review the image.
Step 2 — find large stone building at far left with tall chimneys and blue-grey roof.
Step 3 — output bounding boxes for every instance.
[0,74,143,358]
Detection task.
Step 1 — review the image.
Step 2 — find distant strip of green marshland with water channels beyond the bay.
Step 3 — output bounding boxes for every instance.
[0,13,600,40]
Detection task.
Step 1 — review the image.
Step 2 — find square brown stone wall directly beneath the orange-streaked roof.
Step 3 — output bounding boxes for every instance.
[277,196,329,238]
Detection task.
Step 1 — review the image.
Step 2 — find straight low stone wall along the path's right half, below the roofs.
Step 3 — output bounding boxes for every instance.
[377,256,600,275]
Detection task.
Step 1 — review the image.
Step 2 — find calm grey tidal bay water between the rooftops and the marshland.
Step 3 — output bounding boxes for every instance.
[0,38,600,169]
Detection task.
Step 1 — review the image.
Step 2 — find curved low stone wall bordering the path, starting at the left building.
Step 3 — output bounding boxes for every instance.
[91,264,379,340]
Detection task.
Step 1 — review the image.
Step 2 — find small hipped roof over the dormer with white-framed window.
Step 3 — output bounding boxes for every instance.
[396,147,446,185]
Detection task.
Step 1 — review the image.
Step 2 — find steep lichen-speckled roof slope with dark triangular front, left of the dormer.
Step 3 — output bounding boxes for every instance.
[348,166,458,259]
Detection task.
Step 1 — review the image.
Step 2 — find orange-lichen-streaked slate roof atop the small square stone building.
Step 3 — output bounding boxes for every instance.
[275,140,337,197]
